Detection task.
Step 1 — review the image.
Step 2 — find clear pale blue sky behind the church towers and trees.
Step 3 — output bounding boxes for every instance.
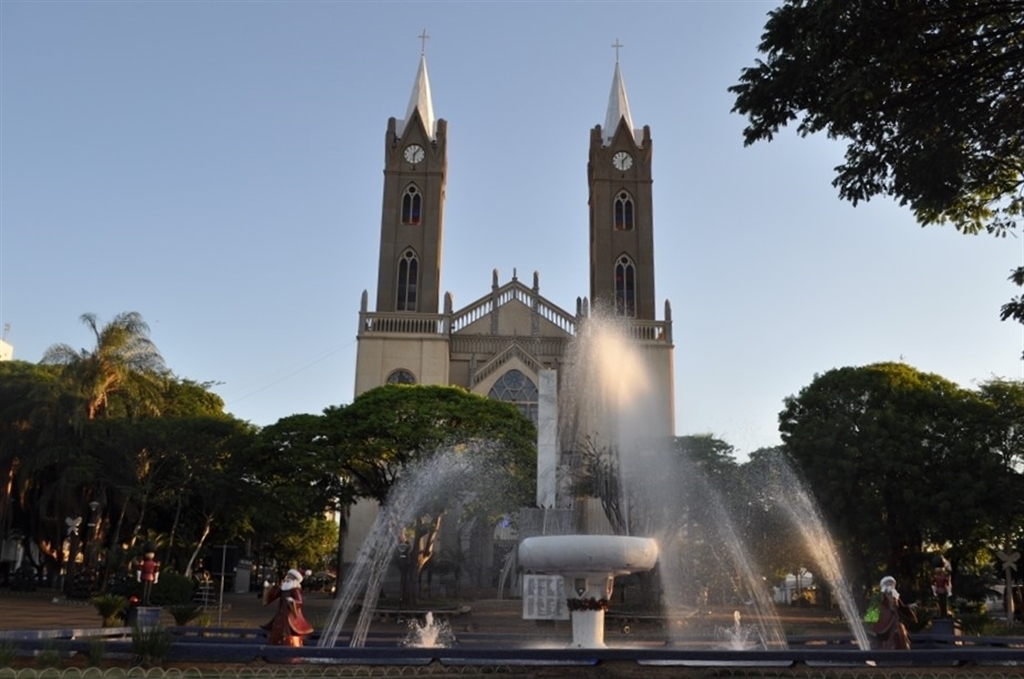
[0,0,1024,459]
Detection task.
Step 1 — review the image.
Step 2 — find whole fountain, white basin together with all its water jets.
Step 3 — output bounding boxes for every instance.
[319,314,869,650]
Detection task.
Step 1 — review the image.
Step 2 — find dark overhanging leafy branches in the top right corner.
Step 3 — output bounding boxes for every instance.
[729,0,1024,350]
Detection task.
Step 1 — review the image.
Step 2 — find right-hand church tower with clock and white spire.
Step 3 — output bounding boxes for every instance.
[587,56,655,321]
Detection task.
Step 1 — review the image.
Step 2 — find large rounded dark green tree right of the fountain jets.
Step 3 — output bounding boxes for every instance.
[779,364,1024,584]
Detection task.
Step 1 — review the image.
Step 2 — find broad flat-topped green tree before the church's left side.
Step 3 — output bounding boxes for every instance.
[282,385,537,602]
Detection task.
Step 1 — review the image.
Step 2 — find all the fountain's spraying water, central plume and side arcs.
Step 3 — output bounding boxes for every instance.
[319,315,870,649]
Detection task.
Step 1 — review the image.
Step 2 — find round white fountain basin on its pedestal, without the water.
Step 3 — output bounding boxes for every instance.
[519,536,657,648]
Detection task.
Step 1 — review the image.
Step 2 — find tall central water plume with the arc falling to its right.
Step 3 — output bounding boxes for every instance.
[559,312,786,648]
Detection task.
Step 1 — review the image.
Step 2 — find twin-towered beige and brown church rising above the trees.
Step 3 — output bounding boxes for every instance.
[355,55,674,445]
